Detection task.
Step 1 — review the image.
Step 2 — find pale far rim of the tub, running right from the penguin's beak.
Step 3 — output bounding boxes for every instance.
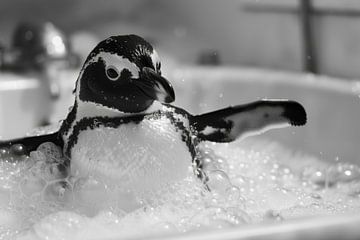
[167,66,360,96]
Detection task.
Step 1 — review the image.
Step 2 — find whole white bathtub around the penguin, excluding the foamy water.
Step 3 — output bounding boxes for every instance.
[0,67,360,240]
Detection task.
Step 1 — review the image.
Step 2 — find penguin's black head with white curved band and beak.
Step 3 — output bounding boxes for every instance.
[76,35,175,113]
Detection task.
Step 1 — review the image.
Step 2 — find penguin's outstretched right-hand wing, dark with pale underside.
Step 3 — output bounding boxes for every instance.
[190,100,306,142]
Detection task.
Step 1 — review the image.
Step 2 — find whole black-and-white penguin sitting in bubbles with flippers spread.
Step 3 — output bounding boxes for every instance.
[0,35,307,189]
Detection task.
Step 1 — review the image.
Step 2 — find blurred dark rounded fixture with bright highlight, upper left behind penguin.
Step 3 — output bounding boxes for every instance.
[1,22,80,72]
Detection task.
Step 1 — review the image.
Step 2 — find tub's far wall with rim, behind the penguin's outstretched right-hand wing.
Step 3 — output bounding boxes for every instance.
[168,67,360,166]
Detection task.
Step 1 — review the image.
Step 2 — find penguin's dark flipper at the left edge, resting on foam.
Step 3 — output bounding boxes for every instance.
[0,132,63,155]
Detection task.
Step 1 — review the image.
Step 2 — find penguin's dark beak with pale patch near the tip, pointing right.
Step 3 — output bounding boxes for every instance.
[135,67,175,103]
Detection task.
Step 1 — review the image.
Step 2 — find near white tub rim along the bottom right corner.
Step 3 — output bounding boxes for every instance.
[141,213,360,240]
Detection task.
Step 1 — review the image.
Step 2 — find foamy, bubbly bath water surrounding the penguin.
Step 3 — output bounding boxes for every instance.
[0,139,360,239]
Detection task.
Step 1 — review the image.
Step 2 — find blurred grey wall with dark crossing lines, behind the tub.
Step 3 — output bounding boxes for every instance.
[0,0,360,79]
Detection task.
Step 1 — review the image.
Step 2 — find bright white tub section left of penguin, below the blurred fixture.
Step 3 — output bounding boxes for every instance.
[0,70,78,139]
